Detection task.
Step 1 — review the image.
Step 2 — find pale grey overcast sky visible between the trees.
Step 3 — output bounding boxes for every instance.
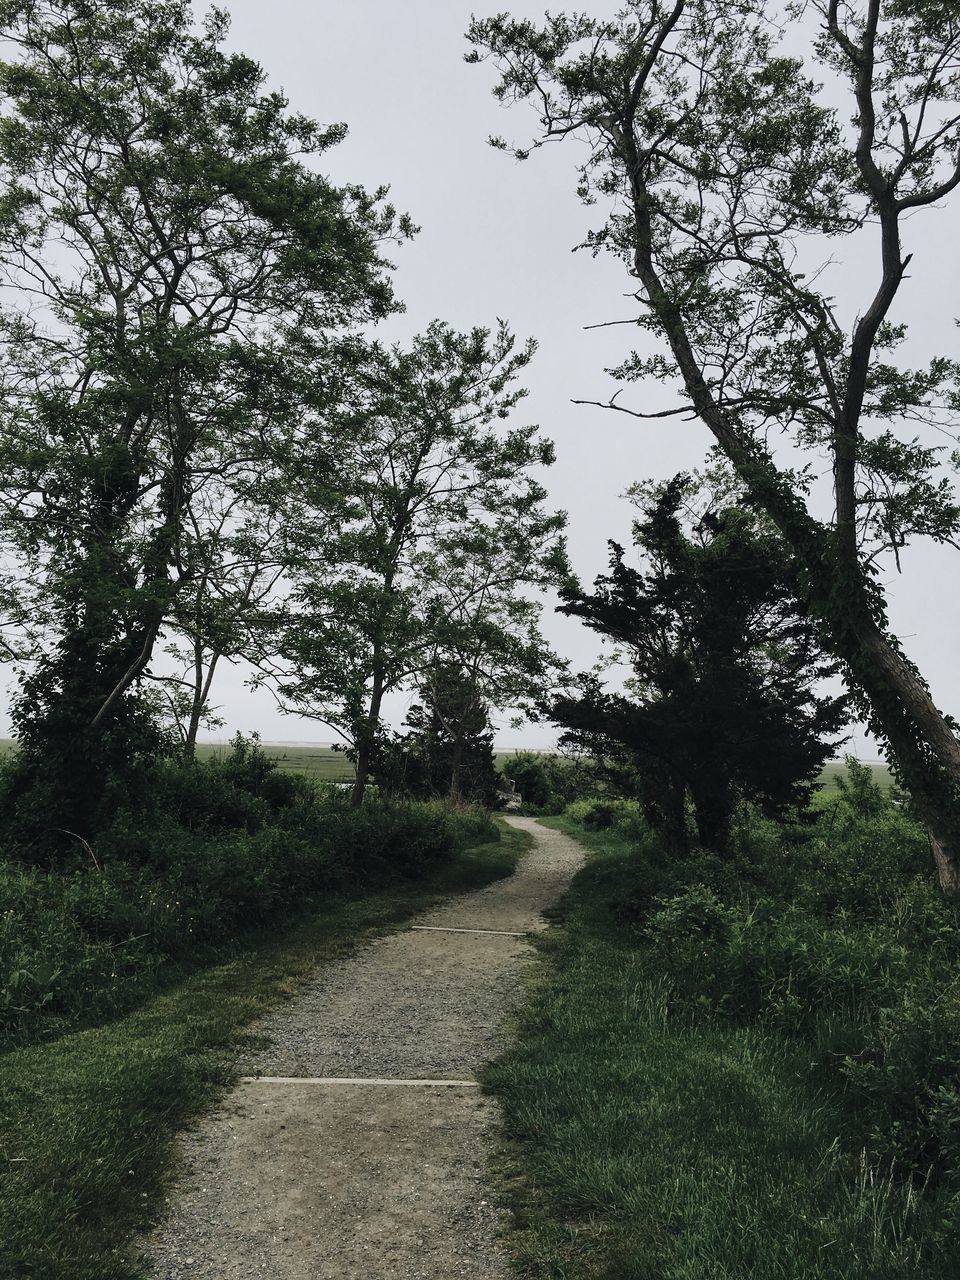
[11,0,960,756]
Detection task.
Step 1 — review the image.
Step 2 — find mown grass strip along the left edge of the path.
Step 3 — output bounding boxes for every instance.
[0,826,529,1280]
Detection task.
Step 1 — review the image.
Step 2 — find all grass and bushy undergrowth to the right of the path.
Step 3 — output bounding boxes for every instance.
[488,764,960,1280]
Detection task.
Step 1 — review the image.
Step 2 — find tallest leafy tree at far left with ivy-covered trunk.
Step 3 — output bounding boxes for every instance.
[0,0,410,855]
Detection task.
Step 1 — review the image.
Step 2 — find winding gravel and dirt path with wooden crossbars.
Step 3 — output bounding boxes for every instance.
[142,818,581,1280]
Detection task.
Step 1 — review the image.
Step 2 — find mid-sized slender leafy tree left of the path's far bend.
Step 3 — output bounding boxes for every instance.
[273,321,563,804]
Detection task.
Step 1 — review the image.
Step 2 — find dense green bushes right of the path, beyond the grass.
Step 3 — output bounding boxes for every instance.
[567,768,960,1193]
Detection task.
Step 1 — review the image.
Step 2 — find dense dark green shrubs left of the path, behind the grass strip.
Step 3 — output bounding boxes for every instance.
[0,745,497,1038]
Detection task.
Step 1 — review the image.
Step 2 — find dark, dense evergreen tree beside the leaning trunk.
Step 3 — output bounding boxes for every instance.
[553,476,846,854]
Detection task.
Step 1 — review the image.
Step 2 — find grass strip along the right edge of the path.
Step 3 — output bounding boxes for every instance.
[486,819,956,1280]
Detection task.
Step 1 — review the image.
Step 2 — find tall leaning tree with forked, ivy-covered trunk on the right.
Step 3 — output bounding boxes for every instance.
[468,0,960,893]
